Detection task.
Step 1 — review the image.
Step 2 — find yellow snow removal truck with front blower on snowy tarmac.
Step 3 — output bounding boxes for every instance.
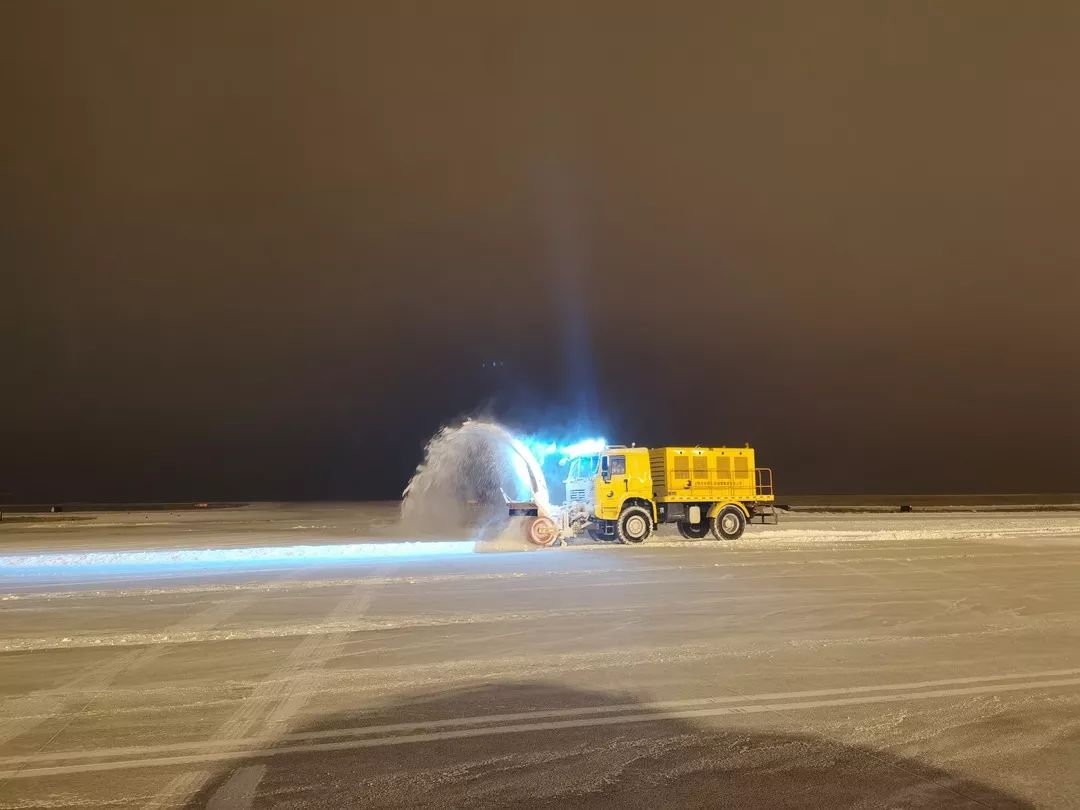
[510,445,777,545]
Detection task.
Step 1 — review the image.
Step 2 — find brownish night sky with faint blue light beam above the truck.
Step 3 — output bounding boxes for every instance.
[0,0,1080,502]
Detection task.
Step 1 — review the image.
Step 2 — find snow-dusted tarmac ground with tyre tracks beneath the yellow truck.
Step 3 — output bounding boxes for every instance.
[0,504,1080,809]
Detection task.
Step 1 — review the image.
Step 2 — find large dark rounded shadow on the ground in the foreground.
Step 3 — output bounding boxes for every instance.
[189,684,1031,809]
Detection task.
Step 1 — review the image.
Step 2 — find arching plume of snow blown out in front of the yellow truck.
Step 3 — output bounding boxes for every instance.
[402,419,551,534]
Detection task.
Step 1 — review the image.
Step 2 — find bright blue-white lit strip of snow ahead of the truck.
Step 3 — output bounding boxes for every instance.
[0,540,476,570]
